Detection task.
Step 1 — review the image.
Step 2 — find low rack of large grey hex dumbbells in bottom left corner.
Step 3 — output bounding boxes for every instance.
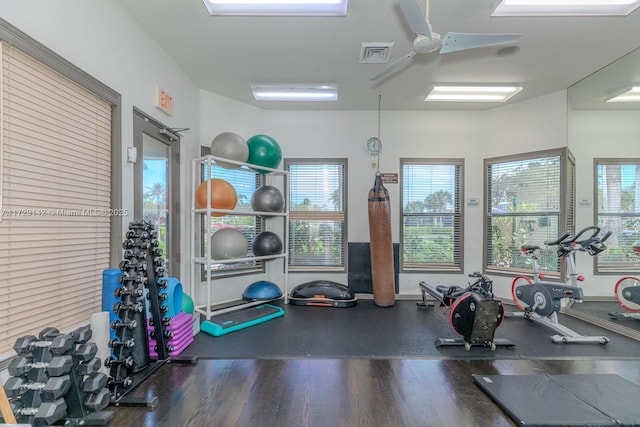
[5,326,113,426]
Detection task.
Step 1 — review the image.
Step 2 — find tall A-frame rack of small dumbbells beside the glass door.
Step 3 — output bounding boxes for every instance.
[105,221,180,407]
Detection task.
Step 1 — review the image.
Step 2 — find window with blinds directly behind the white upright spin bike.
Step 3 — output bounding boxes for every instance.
[484,149,575,278]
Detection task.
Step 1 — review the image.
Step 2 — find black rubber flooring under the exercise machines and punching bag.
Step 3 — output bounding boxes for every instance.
[180,299,640,359]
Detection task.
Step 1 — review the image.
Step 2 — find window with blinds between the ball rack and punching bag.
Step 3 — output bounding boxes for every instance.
[285,159,347,271]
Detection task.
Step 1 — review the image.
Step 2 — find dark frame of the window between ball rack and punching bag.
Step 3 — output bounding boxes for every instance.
[284,158,349,273]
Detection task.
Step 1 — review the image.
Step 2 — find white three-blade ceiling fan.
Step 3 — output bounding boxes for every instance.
[371,0,522,81]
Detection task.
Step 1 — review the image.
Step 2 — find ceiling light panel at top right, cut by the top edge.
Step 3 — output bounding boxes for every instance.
[491,0,640,16]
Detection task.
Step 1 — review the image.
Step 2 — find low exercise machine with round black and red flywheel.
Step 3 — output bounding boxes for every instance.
[417,272,515,351]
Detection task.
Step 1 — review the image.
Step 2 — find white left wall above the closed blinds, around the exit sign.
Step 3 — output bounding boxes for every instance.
[0,0,199,284]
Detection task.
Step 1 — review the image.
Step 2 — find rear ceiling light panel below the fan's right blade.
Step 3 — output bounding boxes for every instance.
[424,85,522,102]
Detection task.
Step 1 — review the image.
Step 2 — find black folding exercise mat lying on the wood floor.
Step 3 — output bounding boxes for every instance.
[473,374,640,426]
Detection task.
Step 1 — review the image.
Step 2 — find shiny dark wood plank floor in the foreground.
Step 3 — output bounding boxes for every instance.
[108,360,640,427]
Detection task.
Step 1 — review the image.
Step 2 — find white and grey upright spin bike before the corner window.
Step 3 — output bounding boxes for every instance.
[507,226,611,344]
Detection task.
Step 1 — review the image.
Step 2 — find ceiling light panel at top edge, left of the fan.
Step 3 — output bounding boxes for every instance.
[203,0,347,16]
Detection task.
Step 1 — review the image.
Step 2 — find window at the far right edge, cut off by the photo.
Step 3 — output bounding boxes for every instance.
[594,159,640,273]
